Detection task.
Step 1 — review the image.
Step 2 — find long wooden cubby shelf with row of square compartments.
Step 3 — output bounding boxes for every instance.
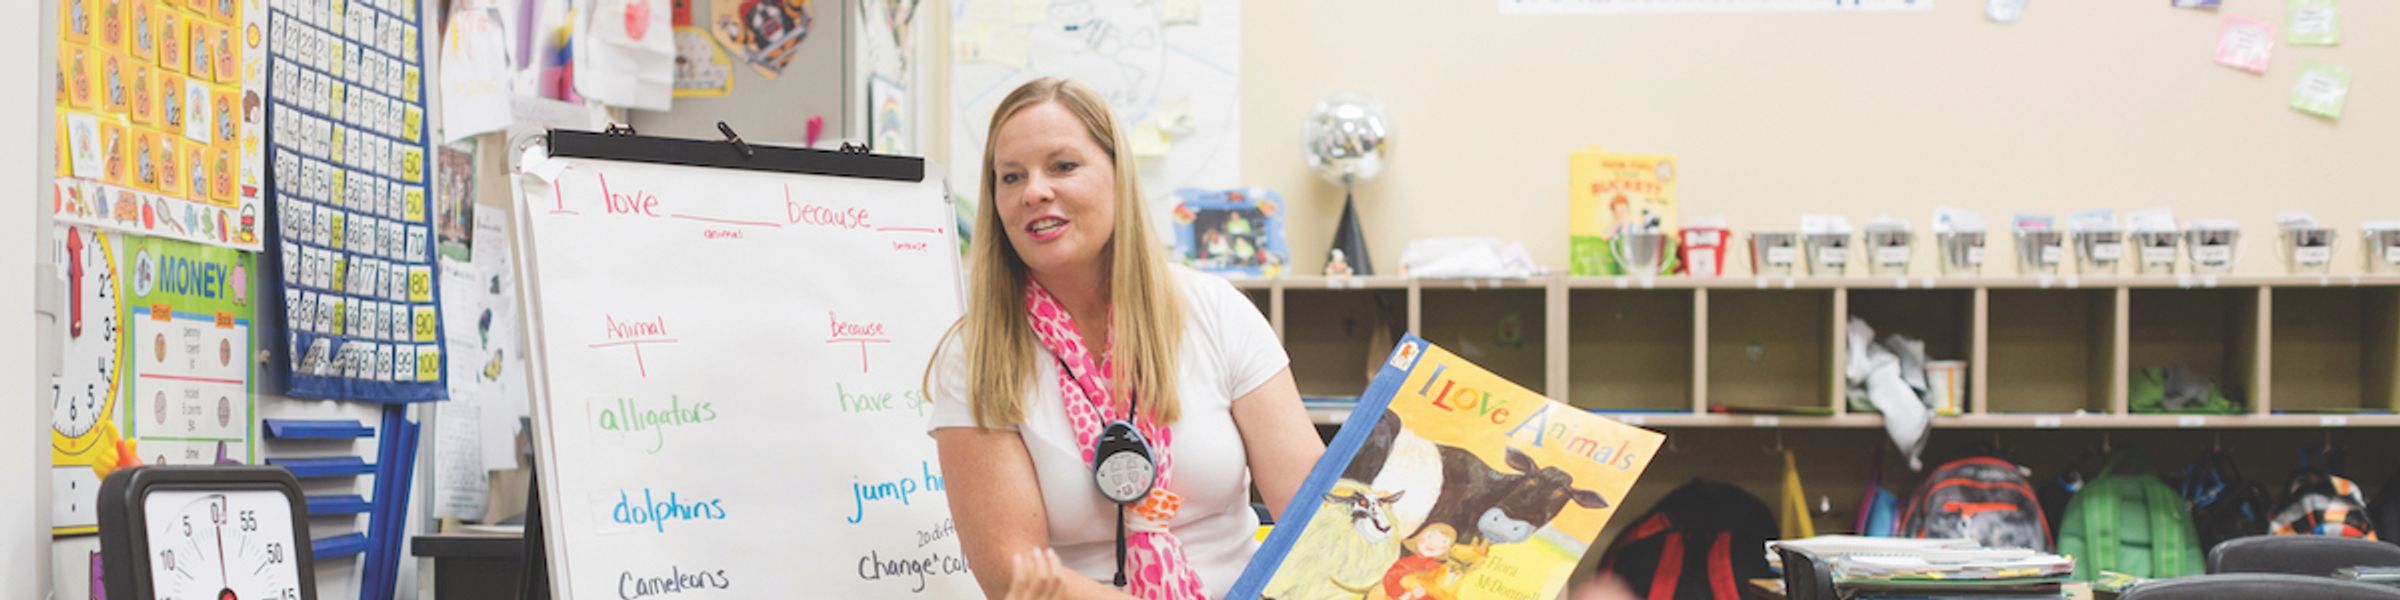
[1234,276,2400,430]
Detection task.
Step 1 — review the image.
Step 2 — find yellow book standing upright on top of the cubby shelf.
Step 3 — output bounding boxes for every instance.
[1567,146,1675,276]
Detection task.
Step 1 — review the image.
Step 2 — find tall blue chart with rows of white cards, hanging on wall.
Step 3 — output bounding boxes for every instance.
[266,0,449,401]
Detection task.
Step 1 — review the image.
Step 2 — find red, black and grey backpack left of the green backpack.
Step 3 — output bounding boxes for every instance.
[1901,456,2050,552]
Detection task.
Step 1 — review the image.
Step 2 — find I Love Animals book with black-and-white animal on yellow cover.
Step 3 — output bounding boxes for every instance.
[1229,334,1666,600]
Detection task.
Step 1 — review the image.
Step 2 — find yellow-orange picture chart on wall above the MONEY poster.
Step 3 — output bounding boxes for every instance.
[50,0,266,252]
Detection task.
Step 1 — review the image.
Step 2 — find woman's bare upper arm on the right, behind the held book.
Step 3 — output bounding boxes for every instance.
[1234,367,1325,514]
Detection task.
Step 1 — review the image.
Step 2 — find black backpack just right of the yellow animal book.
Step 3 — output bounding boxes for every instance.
[1601,480,1776,600]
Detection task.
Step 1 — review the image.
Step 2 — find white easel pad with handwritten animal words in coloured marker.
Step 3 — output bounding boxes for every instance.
[516,146,974,598]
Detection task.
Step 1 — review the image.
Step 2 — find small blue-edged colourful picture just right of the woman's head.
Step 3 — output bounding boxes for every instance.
[1171,187,1291,276]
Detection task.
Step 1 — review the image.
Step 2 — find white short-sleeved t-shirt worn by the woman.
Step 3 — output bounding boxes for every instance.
[926,266,1291,598]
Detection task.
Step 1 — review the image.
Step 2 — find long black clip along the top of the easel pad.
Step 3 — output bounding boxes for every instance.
[545,130,924,182]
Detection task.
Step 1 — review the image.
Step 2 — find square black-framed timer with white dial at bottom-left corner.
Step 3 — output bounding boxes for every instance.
[101,466,317,600]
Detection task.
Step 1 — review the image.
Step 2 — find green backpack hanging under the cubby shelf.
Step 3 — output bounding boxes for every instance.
[2059,451,2208,581]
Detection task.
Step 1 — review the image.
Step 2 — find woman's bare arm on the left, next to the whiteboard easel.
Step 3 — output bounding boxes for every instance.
[934,427,1133,600]
